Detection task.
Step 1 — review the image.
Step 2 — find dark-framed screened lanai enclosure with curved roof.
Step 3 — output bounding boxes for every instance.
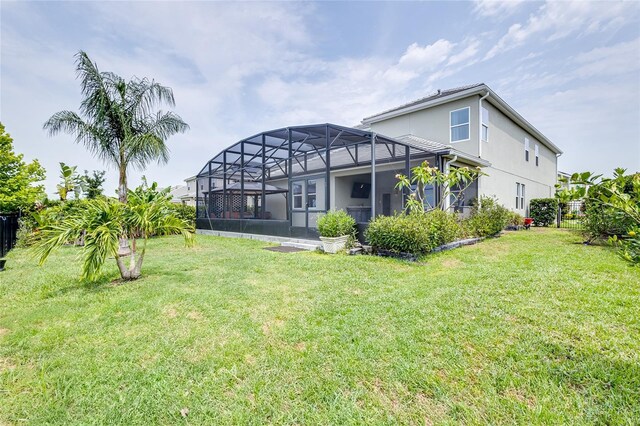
[196,124,470,238]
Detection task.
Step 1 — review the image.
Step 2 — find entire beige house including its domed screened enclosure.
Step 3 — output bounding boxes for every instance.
[194,84,561,237]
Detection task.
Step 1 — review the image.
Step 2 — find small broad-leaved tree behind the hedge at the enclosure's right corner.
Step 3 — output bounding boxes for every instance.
[396,161,485,213]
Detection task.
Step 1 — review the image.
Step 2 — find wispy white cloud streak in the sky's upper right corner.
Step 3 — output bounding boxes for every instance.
[485,1,639,59]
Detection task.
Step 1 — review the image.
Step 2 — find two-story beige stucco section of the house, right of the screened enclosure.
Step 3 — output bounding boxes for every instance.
[361,84,562,215]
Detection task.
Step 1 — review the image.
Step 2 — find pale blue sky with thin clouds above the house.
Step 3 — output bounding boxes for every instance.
[0,0,640,195]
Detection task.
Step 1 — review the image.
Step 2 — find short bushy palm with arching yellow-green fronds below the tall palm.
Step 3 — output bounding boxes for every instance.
[34,183,193,280]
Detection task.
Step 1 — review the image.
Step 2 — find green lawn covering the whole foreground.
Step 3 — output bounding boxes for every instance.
[0,229,640,425]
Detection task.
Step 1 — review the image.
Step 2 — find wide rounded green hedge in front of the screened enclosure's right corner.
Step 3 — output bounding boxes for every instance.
[365,210,463,255]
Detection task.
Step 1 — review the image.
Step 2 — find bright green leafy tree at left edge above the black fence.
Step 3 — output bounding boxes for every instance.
[0,123,45,213]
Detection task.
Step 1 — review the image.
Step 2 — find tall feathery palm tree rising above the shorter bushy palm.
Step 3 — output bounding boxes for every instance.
[44,51,189,203]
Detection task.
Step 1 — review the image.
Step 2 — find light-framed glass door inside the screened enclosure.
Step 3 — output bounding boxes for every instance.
[291,176,327,234]
